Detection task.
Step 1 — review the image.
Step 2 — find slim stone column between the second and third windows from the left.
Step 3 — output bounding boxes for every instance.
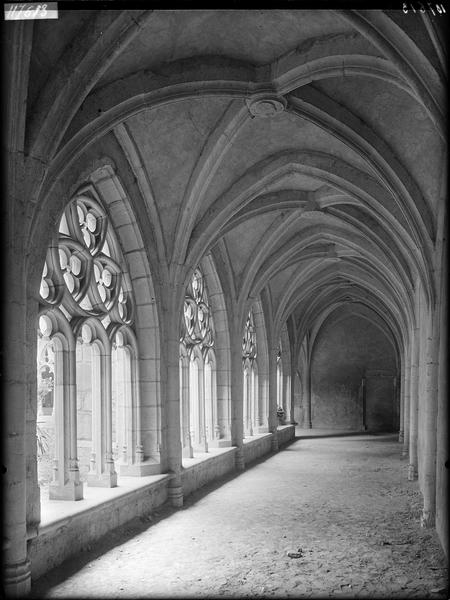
[230,327,245,471]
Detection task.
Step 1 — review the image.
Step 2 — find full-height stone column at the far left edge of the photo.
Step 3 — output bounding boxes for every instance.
[0,21,33,598]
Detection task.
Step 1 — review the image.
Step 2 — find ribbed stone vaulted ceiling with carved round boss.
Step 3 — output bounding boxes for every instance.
[25,5,446,358]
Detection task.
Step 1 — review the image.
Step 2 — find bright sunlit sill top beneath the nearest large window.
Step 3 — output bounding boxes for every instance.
[39,474,171,534]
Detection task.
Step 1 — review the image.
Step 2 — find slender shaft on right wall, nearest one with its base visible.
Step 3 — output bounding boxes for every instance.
[420,314,439,527]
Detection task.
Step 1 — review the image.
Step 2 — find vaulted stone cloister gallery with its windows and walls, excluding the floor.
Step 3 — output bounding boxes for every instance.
[2,3,448,597]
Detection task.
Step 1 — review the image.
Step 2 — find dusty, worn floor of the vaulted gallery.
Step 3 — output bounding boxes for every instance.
[32,430,448,598]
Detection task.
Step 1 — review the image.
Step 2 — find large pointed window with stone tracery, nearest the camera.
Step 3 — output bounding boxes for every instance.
[38,192,143,500]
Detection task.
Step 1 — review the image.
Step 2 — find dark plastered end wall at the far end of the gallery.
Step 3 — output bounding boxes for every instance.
[311,315,396,431]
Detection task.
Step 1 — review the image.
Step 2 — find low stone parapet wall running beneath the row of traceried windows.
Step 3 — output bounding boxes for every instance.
[29,425,295,580]
